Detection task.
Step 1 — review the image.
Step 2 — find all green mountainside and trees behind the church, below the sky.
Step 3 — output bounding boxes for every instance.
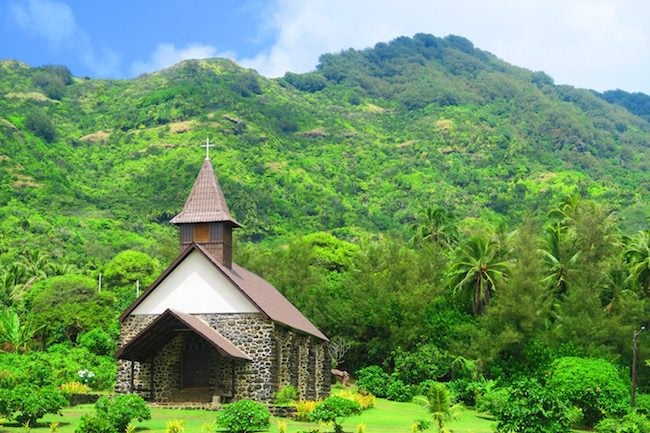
[0,34,650,430]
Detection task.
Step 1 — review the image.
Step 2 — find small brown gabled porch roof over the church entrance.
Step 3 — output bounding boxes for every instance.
[116,309,251,362]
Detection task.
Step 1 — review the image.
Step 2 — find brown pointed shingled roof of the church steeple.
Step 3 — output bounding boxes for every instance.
[170,158,241,227]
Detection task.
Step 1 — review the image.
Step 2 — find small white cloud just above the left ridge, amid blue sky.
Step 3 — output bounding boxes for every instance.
[131,43,235,76]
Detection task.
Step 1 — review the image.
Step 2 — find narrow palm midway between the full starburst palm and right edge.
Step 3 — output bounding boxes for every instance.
[541,222,580,295]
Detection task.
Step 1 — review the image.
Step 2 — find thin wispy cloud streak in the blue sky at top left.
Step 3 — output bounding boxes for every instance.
[9,0,119,77]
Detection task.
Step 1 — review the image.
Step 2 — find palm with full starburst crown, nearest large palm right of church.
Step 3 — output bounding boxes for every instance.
[451,236,510,314]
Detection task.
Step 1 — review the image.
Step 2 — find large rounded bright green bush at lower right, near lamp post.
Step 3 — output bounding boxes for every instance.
[547,357,630,426]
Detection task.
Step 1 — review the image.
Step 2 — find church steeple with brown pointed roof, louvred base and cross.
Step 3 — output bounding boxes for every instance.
[170,150,241,268]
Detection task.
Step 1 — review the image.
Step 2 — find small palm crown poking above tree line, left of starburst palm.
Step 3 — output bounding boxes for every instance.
[410,206,458,248]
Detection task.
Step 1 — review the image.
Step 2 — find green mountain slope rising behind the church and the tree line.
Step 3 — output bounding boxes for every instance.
[0,34,650,266]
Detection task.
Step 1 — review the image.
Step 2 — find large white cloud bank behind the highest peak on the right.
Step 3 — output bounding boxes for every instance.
[240,0,650,92]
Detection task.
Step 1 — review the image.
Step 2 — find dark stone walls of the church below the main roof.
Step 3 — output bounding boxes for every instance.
[115,313,330,403]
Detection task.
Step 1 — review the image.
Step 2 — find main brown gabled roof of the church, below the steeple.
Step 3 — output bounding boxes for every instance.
[120,244,328,341]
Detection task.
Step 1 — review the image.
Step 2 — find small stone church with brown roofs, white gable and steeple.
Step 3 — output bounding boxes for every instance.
[116,157,330,403]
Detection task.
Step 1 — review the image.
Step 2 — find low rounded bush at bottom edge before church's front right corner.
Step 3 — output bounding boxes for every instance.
[217,400,271,433]
